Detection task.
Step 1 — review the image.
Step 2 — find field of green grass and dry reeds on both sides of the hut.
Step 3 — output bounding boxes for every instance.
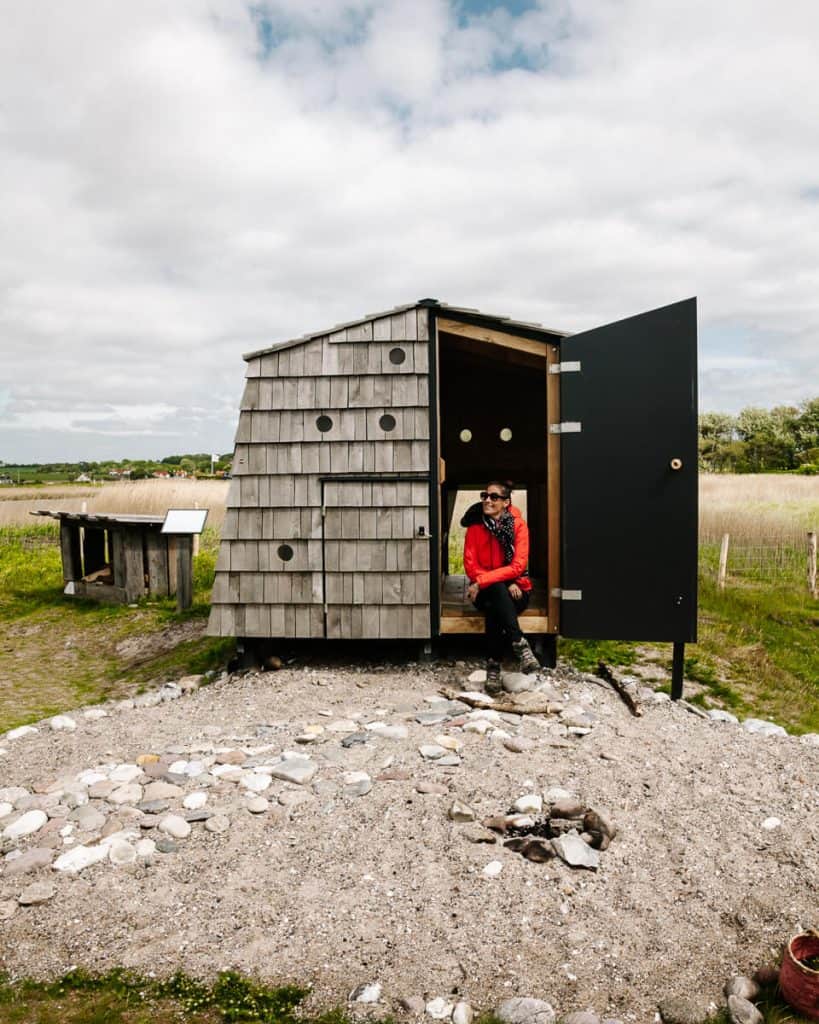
[0,474,819,732]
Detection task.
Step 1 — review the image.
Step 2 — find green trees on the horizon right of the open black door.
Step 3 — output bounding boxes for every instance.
[699,398,819,474]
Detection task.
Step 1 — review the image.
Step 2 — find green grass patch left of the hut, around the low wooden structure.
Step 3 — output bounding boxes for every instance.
[0,523,234,732]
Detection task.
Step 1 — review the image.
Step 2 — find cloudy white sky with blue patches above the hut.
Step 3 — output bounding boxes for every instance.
[0,0,819,462]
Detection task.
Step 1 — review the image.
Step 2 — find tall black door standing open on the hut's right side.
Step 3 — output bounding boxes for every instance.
[560,299,697,641]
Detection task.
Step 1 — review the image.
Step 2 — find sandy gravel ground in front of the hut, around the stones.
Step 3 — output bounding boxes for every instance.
[0,662,819,1021]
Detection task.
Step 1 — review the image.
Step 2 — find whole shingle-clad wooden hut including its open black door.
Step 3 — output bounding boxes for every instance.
[209,299,697,692]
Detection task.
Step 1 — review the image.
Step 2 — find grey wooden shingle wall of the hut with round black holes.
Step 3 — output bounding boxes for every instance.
[209,307,430,638]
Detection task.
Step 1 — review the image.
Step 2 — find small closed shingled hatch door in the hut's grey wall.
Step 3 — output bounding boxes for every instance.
[322,478,432,639]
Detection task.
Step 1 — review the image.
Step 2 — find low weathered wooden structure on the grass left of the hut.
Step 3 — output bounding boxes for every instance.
[32,509,192,607]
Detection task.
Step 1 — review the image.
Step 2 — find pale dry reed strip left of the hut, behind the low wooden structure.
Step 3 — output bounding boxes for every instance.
[0,479,229,529]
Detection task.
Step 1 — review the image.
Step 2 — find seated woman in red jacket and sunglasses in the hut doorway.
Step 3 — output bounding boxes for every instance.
[461,480,541,693]
